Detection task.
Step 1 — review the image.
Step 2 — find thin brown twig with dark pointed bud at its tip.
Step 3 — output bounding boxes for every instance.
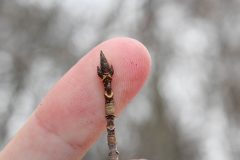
[97,51,119,160]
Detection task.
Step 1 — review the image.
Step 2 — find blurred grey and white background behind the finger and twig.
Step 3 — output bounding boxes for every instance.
[0,0,240,160]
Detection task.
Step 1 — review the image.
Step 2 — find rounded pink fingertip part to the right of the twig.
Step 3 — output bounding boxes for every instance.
[99,37,151,112]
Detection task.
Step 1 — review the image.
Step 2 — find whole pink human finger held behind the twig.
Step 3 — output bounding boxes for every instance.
[0,38,151,160]
